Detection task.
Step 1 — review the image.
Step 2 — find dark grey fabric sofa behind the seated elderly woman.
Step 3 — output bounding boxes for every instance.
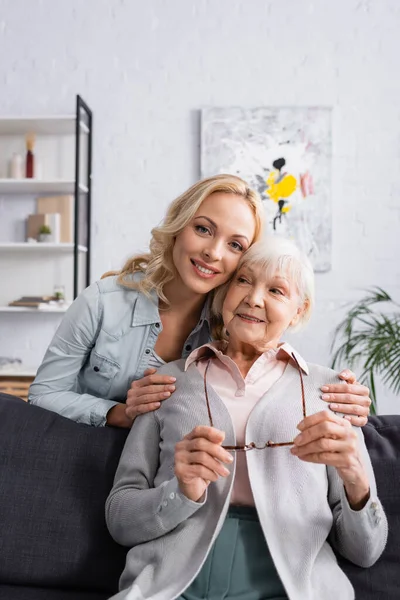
[0,394,400,600]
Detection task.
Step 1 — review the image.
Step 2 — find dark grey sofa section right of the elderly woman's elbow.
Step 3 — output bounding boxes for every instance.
[339,415,400,600]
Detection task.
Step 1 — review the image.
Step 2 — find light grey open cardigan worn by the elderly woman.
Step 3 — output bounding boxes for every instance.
[106,360,387,600]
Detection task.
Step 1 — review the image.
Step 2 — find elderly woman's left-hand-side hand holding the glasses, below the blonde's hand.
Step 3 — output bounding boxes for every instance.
[175,426,233,502]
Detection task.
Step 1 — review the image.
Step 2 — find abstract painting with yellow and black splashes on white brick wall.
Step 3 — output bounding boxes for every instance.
[201,107,332,271]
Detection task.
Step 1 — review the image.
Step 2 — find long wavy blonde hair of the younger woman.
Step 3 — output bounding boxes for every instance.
[103,175,264,305]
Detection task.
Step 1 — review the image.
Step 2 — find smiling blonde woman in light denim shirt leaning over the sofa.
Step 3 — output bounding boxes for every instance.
[29,175,370,428]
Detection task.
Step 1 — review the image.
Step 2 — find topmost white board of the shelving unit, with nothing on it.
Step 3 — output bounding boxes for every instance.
[0,115,89,135]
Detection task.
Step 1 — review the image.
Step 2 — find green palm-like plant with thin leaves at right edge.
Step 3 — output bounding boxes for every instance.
[331,287,400,414]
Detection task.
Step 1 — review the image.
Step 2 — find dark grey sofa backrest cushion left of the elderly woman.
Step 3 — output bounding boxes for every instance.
[0,394,127,598]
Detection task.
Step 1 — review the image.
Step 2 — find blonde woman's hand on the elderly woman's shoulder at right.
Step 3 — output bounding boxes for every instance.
[321,369,371,427]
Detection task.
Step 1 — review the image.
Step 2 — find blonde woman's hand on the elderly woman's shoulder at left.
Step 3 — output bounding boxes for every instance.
[125,369,176,425]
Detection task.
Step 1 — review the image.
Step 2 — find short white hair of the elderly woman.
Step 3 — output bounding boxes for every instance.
[211,235,315,338]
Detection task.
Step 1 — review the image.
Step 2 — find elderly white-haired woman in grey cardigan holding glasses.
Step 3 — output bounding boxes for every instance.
[106,237,387,600]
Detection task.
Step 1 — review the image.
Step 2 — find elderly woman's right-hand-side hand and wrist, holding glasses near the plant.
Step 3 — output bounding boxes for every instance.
[291,410,369,510]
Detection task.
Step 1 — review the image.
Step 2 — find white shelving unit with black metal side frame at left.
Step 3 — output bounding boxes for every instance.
[0,96,92,377]
